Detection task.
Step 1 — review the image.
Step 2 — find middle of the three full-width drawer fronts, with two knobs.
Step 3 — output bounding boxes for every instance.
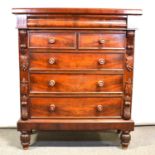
[30,73,123,93]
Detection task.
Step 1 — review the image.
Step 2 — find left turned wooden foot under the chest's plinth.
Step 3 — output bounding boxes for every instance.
[20,131,30,150]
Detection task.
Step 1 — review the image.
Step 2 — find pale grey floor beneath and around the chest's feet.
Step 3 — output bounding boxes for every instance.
[0,126,155,155]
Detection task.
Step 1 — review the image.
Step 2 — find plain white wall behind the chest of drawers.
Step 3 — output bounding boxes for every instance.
[0,0,155,127]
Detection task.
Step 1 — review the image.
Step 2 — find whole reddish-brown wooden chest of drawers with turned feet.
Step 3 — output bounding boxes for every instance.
[13,8,141,149]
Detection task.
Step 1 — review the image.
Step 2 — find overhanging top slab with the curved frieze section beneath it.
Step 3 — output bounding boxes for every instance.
[12,8,142,29]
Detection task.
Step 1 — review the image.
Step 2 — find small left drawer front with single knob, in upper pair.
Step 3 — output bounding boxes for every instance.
[29,32,76,49]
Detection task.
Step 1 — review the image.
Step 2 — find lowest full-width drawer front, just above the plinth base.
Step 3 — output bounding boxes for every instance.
[30,98,122,118]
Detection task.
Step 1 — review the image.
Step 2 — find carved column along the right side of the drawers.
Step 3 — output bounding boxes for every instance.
[123,30,135,120]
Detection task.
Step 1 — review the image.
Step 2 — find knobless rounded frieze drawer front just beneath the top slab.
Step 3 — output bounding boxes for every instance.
[27,15,127,28]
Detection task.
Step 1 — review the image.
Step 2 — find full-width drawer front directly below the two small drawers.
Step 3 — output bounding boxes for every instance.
[30,53,124,70]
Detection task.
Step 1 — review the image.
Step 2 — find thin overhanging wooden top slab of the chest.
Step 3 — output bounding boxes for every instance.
[12,8,142,15]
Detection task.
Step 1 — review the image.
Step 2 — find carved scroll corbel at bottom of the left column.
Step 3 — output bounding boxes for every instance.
[21,95,28,120]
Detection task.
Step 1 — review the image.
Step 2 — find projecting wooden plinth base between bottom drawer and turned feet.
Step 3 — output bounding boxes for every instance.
[17,118,134,131]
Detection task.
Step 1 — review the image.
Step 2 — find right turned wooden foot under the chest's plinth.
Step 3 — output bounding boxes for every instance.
[120,131,131,149]
